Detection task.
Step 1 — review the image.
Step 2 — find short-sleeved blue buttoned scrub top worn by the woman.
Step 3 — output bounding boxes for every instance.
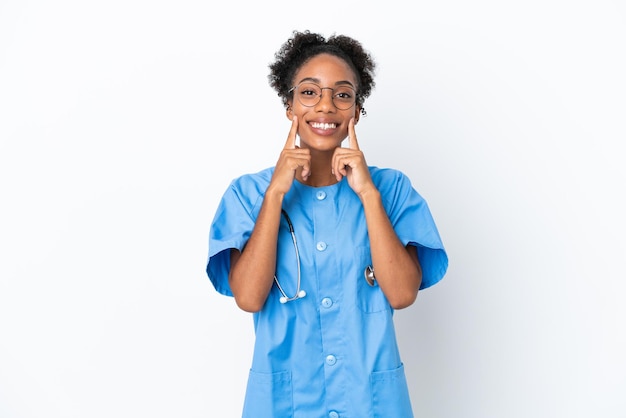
[207,167,448,418]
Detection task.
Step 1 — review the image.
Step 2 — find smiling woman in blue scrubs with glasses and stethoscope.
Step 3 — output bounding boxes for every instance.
[207,31,448,418]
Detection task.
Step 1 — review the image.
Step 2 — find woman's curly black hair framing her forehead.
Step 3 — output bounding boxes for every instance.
[268,30,376,113]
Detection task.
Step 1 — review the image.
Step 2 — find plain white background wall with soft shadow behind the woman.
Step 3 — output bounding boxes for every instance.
[0,0,626,418]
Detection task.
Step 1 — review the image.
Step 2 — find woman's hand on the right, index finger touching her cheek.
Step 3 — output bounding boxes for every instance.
[332,118,375,195]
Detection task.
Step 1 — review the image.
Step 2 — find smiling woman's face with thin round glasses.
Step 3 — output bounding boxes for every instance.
[287,54,360,151]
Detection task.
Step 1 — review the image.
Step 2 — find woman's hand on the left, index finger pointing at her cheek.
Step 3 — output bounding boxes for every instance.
[268,116,311,195]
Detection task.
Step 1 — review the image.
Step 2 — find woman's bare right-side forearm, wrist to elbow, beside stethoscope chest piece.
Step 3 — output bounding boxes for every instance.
[360,189,422,309]
